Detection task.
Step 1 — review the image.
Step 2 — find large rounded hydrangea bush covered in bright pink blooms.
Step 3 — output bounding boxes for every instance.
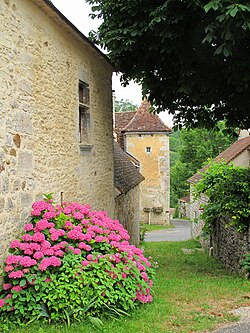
[0,200,155,322]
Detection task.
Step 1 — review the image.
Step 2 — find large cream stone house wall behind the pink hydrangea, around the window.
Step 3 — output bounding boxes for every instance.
[0,0,114,264]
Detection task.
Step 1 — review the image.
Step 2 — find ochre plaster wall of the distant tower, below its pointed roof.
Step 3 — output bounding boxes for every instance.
[125,133,170,224]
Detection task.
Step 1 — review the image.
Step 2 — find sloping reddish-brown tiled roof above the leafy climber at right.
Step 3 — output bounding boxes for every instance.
[187,136,250,183]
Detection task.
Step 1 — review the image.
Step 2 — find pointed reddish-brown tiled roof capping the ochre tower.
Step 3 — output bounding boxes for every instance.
[122,100,171,132]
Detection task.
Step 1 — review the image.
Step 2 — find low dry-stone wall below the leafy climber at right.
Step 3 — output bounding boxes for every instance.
[211,219,250,273]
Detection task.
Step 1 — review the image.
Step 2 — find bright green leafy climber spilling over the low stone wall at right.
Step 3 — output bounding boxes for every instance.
[196,162,250,232]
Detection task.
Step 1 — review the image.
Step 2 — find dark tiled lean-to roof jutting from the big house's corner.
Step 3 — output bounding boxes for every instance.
[114,142,145,194]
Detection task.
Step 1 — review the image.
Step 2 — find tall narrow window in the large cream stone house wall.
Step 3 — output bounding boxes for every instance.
[79,81,90,144]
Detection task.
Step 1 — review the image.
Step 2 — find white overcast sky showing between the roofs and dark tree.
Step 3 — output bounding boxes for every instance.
[52,0,172,126]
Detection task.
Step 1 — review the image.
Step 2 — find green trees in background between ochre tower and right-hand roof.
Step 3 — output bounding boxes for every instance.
[170,122,235,207]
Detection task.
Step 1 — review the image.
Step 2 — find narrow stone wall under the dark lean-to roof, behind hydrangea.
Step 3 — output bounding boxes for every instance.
[115,185,141,246]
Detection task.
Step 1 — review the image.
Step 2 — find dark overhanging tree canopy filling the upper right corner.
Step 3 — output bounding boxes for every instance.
[87,0,250,128]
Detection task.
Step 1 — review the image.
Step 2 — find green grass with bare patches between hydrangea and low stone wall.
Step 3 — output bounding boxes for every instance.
[2,241,250,333]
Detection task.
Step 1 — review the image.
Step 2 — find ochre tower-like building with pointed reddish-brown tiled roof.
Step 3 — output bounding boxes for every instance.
[115,101,171,224]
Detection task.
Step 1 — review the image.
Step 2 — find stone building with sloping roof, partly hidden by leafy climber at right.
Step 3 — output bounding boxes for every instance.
[188,133,250,238]
